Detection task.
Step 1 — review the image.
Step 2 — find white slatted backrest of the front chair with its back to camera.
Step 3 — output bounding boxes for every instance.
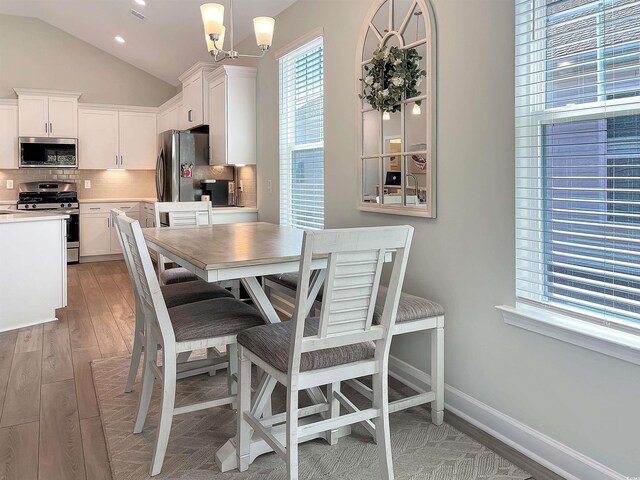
[289,225,413,371]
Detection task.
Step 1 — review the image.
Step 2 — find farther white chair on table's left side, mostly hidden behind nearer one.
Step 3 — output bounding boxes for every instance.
[111,208,233,393]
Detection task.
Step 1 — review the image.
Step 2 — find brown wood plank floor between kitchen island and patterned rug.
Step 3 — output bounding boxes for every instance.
[0,262,135,480]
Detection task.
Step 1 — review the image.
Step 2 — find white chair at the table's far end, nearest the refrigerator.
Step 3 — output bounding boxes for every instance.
[154,202,213,285]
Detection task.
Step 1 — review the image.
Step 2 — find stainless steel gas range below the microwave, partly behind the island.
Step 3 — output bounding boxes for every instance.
[18,181,80,263]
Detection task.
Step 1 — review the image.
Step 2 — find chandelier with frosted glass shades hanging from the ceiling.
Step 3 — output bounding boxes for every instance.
[200,0,276,62]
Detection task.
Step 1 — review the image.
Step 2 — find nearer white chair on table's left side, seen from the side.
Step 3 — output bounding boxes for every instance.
[116,215,264,476]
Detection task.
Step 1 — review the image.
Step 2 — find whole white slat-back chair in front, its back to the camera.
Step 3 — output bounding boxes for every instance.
[237,226,413,479]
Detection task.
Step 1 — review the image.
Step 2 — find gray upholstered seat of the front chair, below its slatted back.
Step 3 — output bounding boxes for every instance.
[237,318,375,372]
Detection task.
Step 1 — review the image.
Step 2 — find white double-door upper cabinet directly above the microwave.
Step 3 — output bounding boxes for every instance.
[15,89,80,138]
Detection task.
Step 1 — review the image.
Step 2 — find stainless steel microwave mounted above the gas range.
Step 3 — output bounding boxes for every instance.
[20,137,78,168]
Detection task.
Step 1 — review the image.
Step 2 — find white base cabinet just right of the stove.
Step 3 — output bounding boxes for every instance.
[80,202,144,257]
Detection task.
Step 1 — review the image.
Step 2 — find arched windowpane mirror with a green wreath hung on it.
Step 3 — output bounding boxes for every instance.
[356,0,436,217]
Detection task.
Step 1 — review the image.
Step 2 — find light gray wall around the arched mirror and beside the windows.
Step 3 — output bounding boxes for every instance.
[241,0,640,476]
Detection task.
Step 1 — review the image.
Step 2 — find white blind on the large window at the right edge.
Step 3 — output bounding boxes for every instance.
[516,0,640,333]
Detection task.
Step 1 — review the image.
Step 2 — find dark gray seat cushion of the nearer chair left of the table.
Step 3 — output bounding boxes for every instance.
[169,298,264,342]
